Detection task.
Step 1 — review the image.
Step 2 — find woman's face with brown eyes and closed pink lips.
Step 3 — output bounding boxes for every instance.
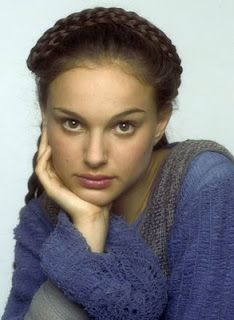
[43,65,169,206]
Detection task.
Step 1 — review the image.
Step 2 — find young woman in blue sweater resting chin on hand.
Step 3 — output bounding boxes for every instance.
[2,8,234,320]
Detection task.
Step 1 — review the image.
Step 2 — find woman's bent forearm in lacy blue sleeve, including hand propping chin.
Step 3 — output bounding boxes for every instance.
[31,124,167,319]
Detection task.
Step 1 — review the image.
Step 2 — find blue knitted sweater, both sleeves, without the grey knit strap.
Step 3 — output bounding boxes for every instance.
[2,152,234,320]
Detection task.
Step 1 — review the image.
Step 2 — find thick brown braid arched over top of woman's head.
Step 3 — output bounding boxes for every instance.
[27,7,182,74]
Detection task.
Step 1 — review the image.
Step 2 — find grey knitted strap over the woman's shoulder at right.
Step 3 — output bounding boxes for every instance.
[140,140,234,275]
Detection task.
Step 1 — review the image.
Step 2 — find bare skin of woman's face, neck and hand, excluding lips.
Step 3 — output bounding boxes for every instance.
[36,64,170,252]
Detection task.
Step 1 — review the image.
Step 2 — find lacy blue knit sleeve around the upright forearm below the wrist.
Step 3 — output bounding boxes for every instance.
[41,211,167,320]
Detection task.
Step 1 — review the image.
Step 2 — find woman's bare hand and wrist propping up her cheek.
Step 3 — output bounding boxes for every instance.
[35,127,111,252]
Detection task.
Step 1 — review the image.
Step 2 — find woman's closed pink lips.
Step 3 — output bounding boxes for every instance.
[77,174,114,189]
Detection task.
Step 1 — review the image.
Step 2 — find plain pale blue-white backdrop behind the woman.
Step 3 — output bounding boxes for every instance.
[0,0,234,314]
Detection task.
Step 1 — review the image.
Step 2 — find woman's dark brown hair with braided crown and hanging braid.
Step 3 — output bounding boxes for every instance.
[25,7,182,203]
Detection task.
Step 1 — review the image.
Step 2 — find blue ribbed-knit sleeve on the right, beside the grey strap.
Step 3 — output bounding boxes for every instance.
[166,155,234,320]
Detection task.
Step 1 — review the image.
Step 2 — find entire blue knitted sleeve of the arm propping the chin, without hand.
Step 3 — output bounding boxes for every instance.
[2,199,166,320]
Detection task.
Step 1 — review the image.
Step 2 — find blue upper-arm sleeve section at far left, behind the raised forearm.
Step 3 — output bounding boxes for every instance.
[2,199,51,320]
